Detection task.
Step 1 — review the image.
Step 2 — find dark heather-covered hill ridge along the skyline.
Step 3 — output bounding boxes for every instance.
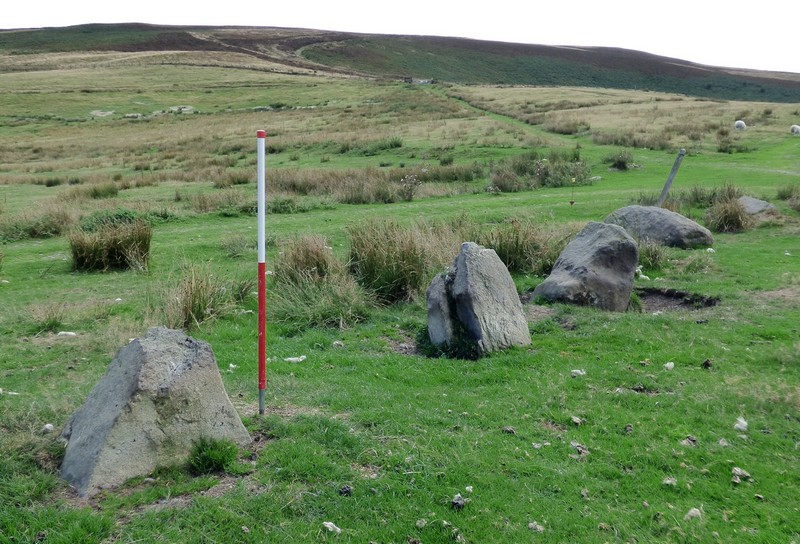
[0,24,800,102]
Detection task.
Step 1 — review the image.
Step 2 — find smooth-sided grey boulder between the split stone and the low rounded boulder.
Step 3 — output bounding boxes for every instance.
[533,222,639,312]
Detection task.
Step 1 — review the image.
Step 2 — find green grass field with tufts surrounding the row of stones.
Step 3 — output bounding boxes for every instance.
[0,43,800,544]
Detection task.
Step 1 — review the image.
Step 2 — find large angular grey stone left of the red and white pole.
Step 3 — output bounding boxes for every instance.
[61,327,250,496]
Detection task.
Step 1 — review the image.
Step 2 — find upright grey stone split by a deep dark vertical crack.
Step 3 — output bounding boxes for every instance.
[426,242,531,355]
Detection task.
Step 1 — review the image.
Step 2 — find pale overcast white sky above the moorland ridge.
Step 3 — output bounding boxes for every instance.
[0,0,800,73]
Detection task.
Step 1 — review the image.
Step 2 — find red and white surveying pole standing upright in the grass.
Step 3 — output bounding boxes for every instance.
[256,130,267,415]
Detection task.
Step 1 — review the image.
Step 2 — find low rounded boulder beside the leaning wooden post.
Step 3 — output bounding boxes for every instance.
[605,206,714,249]
